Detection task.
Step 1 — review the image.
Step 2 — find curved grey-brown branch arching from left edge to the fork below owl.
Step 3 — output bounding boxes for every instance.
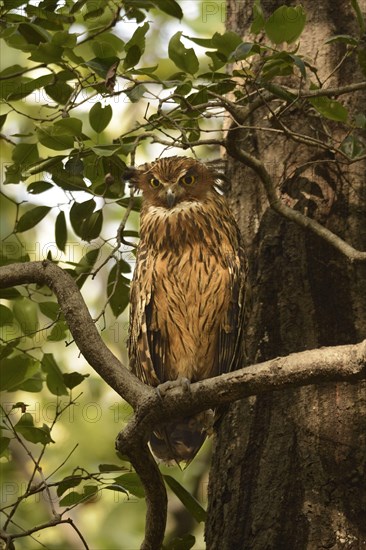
[0,261,153,408]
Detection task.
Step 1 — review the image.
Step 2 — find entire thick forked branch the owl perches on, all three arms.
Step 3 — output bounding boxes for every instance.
[0,261,366,550]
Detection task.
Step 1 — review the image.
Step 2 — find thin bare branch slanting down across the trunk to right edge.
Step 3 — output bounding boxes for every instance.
[226,133,366,262]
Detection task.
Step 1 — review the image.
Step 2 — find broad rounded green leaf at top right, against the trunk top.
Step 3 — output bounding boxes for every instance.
[264,5,306,44]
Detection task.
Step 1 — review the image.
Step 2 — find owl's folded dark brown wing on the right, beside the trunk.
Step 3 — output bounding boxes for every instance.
[214,243,246,376]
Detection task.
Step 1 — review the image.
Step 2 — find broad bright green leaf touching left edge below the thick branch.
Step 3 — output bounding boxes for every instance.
[0,355,40,391]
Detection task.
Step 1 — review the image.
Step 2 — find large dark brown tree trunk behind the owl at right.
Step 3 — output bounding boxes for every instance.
[206,0,366,550]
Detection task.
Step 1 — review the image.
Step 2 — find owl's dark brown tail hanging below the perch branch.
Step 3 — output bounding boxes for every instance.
[150,409,214,466]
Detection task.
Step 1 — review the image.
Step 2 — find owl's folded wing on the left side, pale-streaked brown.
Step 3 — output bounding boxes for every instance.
[128,243,161,386]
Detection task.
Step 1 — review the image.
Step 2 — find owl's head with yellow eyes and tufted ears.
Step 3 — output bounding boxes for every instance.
[124,157,222,209]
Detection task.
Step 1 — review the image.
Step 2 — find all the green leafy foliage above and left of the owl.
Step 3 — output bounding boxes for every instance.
[0,0,366,548]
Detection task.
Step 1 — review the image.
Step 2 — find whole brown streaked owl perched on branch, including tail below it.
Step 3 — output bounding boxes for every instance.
[128,156,245,464]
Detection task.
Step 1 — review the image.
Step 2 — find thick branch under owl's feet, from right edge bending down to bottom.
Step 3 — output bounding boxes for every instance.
[116,340,366,550]
